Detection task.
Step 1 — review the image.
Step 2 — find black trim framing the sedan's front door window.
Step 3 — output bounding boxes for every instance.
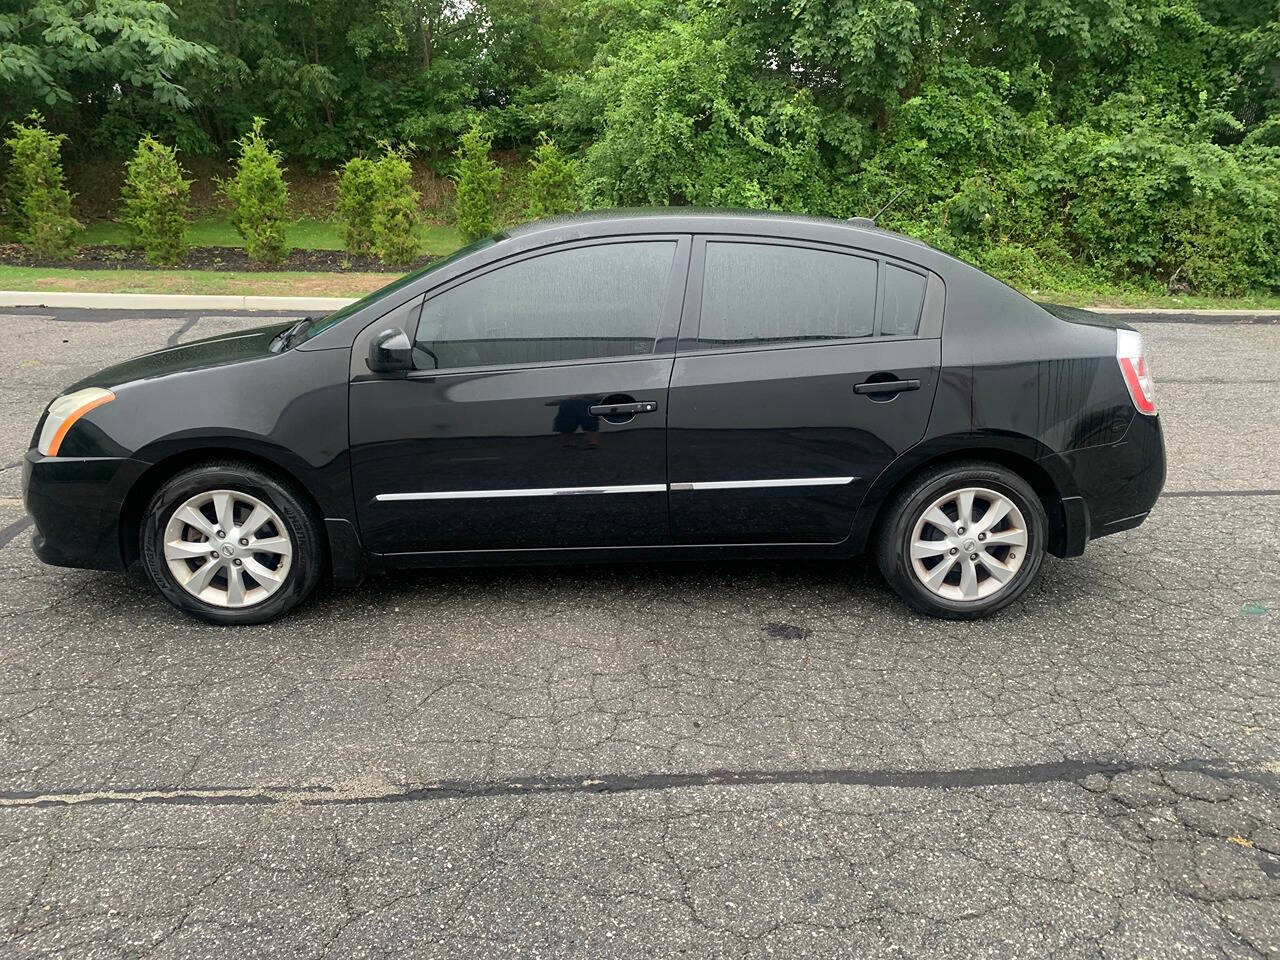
[384,233,692,380]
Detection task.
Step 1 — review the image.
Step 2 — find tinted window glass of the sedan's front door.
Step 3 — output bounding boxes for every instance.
[413,241,676,370]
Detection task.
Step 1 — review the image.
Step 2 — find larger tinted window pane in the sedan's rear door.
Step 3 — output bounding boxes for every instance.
[698,242,876,348]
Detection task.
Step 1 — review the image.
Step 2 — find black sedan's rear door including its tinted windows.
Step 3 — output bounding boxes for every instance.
[667,237,943,544]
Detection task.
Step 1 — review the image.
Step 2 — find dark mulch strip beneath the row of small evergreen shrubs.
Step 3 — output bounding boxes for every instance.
[0,243,438,274]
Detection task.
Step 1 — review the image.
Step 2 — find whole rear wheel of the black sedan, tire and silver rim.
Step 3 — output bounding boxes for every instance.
[877,463,1048,620]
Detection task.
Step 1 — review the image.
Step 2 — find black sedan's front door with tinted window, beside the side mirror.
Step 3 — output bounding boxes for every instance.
[351,237,689,553]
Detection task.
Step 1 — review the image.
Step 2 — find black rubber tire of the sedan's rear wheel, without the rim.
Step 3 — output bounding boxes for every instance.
[876,461,1048,620]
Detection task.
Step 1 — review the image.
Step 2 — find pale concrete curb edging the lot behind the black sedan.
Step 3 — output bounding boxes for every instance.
[0,291,1280,317]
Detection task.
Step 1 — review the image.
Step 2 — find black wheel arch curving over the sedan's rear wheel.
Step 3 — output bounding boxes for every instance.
[850,435,1087,557]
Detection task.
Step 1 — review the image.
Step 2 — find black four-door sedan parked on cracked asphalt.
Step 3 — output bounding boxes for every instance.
[24,212,1165,623]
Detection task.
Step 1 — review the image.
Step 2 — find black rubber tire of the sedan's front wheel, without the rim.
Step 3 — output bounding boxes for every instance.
[140,461,325,626]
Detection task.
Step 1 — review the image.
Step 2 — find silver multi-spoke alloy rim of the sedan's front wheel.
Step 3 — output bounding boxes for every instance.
[164,490,293,607]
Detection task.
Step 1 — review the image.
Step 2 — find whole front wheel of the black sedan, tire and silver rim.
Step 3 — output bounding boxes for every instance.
[142,462,324,623]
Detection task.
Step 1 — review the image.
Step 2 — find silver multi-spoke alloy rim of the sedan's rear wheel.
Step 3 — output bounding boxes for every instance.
[911,486,1027,602]
